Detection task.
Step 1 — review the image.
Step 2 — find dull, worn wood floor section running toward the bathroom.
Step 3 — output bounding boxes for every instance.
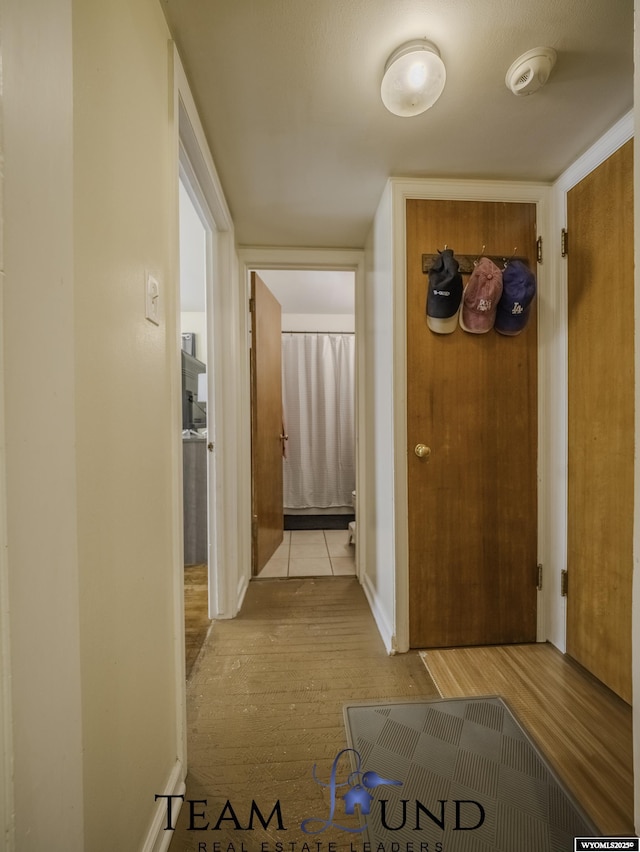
[170,577,438,852]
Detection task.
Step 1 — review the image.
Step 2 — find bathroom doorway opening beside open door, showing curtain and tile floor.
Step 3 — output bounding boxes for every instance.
[252,268,357,578]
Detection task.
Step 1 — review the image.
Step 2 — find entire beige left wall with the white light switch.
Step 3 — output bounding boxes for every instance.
[0,0,183,852]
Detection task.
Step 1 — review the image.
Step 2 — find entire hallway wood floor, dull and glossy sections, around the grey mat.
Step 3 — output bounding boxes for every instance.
[178,569,633,852]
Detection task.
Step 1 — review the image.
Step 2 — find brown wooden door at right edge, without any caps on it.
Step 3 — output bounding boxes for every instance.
[567,141,634,702]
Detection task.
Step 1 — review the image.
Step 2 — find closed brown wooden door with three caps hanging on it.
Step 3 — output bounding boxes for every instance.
[407,200,537,648]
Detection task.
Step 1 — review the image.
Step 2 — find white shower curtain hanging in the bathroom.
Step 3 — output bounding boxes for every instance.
[282,333,355,511]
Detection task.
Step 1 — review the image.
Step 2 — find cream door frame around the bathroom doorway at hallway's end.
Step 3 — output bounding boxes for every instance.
[238,246,367,599]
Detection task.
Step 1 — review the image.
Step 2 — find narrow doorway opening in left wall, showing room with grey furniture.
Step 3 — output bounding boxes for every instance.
[179,176,210,676]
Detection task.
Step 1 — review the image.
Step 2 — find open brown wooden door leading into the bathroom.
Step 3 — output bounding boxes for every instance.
[251,272,284,575]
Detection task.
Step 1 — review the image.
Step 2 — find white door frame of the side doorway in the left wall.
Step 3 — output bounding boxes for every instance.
[167,44,241,736]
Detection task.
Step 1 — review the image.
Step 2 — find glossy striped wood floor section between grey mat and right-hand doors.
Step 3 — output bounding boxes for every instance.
[423,644,634,834]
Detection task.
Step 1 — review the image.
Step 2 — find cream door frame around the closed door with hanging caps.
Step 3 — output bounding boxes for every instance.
[390,178,556,653]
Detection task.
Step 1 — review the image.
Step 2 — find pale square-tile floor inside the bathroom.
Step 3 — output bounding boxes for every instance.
[258,530,356,579]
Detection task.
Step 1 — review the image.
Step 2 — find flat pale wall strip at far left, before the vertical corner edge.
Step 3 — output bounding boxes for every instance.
[2,0,86,852]
